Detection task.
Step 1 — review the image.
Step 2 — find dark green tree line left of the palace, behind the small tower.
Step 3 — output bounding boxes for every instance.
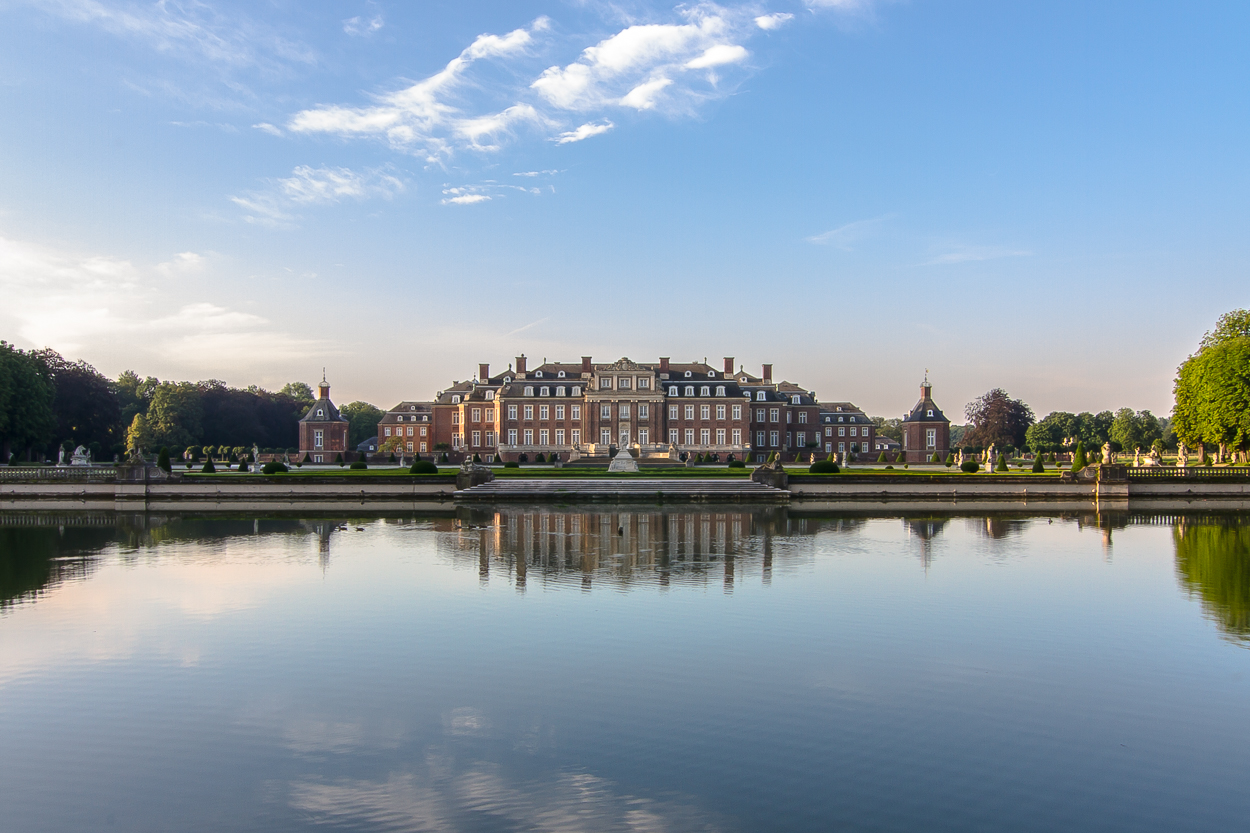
[0,341,383,463]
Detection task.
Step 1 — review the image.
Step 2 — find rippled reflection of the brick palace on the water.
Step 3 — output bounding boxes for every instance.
[435,507,828,592]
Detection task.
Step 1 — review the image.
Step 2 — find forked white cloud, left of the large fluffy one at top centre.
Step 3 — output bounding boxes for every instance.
[286,18,550,161]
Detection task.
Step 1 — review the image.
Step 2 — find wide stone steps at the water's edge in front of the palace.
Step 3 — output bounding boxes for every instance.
[455,478,790,503]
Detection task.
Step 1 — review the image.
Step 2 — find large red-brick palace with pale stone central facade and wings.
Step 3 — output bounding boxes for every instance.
[378,355,840,462]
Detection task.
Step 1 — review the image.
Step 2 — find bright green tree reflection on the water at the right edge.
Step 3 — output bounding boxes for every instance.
[1173,518,1250,642]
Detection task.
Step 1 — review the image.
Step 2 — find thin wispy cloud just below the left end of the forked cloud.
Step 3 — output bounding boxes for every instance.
[230,165,406,228]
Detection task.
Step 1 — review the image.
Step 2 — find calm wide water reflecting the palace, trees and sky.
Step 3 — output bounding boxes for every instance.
[0,507,1250,832]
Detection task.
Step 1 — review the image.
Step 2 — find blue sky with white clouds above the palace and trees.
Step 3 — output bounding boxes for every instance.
[0,0,1250,422]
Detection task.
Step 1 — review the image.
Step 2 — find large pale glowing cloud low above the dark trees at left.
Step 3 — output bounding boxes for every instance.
[0,231,325,365]
